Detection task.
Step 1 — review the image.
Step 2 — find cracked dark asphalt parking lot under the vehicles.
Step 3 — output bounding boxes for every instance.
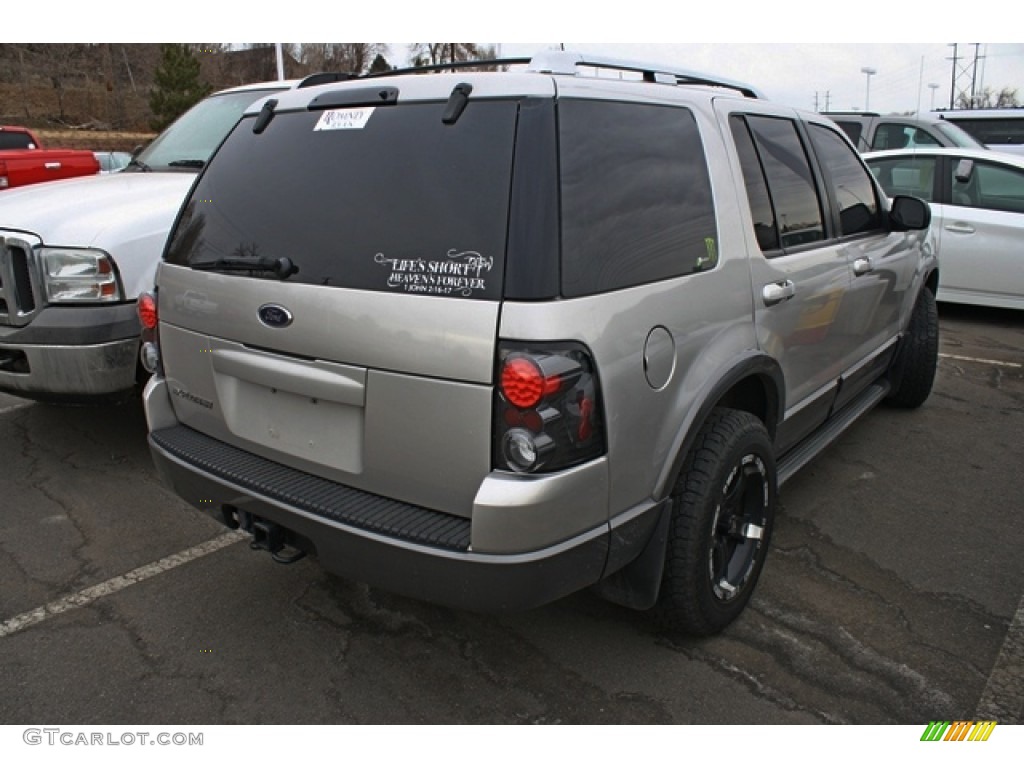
[0,305,1024,726]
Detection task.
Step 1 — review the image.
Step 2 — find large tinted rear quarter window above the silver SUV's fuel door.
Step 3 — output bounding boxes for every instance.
[558,99,718,296]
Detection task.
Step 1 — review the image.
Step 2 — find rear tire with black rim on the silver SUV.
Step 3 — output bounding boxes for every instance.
[654,409,777,637]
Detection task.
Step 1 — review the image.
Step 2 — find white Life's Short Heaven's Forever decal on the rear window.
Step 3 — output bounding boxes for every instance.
[374,248,495,298]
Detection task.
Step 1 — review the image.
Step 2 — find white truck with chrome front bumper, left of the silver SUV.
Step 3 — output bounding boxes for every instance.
[0,83,290,402]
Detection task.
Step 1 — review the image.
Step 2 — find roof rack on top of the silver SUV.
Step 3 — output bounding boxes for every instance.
[298,50,764,98]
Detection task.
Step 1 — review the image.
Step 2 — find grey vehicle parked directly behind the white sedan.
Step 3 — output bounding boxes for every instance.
[822,112,984,152]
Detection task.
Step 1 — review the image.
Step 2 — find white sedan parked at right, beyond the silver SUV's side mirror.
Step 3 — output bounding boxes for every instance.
[865,148,1024,309]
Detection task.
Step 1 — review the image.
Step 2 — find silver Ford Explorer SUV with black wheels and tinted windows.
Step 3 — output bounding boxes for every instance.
[140,52,937,635]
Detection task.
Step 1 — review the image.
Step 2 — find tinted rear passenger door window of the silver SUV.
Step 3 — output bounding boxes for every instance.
[731,115,827,256]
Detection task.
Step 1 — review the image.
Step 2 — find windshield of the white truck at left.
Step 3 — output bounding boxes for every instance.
[137,88,280,170]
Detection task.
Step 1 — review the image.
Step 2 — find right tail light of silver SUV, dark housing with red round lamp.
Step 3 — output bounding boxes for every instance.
[494,343,605,473]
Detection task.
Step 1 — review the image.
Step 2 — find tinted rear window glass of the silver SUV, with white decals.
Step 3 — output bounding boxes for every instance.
[166,100,517,299]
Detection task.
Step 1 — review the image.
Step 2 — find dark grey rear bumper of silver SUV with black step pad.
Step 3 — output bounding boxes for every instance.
[146,382,659,612]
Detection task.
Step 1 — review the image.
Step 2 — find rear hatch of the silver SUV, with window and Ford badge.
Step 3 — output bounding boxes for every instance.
[158,78,540,517]
